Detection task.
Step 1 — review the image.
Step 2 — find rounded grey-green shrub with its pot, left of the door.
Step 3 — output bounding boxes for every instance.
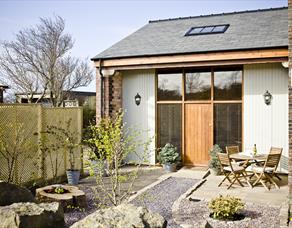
[158,143,180,172]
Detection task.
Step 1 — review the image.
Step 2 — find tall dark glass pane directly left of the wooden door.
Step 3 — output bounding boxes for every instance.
[158,104,181,153]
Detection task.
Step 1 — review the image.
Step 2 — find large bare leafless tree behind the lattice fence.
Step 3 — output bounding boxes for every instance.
[0,16,93,107]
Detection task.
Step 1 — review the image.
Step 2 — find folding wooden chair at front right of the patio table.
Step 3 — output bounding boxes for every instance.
[252,149,282,190]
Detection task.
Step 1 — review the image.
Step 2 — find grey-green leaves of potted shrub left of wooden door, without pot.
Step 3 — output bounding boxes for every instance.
[158,143,181,164]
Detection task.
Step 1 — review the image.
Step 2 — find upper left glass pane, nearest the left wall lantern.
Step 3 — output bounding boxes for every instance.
[157,73,182,101]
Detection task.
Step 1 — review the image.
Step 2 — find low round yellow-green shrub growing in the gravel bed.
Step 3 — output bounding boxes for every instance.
[208,195,244,220]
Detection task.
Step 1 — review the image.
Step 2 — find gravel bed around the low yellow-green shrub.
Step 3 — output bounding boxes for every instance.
[175,199,280,228]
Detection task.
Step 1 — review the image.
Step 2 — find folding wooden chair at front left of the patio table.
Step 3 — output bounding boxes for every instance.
[217,153,251,189]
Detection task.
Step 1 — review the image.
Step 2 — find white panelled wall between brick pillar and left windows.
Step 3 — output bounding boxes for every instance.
[122,70,155,164]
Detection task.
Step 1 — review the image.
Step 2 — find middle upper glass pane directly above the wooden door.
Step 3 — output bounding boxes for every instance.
[185,72,211,100]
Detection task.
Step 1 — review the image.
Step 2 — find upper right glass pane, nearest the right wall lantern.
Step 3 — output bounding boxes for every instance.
[214,71,242,100]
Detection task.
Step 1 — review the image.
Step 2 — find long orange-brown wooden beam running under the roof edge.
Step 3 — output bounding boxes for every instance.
[95,48,288,69]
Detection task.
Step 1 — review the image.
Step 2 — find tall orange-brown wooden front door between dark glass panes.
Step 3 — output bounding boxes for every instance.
[184,104,213,165]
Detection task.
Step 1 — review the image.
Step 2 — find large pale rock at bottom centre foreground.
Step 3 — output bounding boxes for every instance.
[71,204,166,228]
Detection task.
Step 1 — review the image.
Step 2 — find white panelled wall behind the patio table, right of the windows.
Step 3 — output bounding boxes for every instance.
[243,63,288,171]
